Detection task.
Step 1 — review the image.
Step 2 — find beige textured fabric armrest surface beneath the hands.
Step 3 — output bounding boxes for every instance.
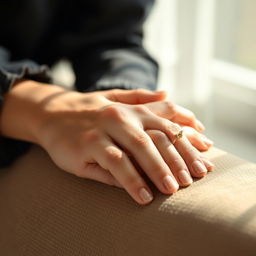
[0,146,256,256]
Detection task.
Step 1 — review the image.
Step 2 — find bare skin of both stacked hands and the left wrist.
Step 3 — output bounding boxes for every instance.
[0,80,213,205]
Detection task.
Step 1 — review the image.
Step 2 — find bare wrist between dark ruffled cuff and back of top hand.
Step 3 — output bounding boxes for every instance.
[0,80,64,143]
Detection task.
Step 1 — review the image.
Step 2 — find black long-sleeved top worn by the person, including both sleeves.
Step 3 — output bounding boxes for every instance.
[0,0,158,167]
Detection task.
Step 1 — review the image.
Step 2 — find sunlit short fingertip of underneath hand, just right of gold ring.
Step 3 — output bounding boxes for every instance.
[182,126,213,151]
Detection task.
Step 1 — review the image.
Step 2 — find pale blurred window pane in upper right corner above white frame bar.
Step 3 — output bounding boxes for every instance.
[214,0,256,71]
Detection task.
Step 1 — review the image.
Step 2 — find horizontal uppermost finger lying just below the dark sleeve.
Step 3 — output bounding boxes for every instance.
[106,89,167,104]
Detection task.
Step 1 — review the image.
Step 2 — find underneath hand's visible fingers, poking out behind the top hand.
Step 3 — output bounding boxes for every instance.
[106,89,213,151]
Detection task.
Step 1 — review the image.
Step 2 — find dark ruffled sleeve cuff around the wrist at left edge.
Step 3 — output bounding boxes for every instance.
[0,46,50,168]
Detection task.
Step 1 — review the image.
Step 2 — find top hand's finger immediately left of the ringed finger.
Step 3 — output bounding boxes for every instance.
[146,130,193,186]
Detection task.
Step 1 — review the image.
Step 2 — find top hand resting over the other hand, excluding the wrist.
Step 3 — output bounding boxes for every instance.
[39,87,214,204]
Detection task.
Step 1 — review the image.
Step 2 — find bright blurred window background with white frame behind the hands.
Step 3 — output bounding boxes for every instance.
[53,0,256,162]
